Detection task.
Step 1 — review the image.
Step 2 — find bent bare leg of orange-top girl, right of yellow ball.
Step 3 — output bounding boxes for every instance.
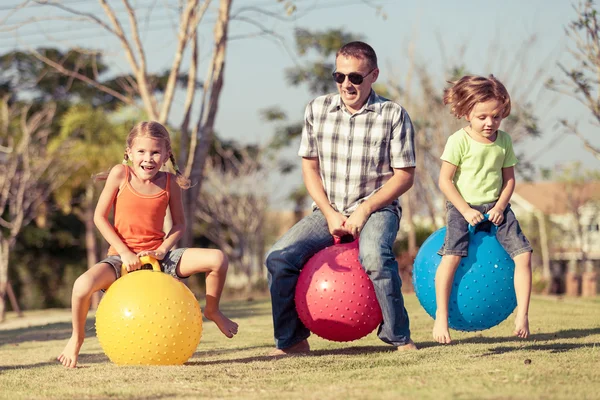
[176,248,238,338]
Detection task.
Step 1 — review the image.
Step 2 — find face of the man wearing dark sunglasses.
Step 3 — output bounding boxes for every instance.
[335,55,379,113]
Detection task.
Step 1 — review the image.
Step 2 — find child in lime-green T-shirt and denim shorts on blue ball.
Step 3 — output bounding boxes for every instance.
[433,75,532,343]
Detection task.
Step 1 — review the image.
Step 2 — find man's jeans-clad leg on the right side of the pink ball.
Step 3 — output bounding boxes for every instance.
[359,209,416,350]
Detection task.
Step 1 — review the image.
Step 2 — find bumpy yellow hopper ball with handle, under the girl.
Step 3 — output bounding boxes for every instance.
[96,257,202,365]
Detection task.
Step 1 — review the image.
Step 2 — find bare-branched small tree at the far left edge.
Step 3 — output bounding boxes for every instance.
[0,95,73,322]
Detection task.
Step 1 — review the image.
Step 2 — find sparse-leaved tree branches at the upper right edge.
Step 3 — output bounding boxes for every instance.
[546,0,600,160]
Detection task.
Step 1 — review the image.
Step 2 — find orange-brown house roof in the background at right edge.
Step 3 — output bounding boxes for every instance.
[513,181,600,215]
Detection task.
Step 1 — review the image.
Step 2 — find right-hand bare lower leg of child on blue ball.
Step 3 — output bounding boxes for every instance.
[514,251,531,339]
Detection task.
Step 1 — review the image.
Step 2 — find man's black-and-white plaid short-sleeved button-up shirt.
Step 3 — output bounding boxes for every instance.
[298,91,416,215]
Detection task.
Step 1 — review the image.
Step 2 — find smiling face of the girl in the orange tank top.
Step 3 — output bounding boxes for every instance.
[127,137,170,180]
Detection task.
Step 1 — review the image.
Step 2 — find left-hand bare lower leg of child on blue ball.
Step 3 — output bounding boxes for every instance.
[433,255,462,344]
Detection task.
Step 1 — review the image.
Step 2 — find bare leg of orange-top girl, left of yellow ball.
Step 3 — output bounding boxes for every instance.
[57,263,116,368]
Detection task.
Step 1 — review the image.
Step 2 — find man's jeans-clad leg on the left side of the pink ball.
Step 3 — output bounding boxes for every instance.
[265,210,333,354]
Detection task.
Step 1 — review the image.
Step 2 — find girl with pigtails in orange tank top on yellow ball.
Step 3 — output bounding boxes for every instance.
[58,122,238,368]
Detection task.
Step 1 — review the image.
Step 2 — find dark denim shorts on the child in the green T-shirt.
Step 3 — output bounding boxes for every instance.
[438,201,533,258]
